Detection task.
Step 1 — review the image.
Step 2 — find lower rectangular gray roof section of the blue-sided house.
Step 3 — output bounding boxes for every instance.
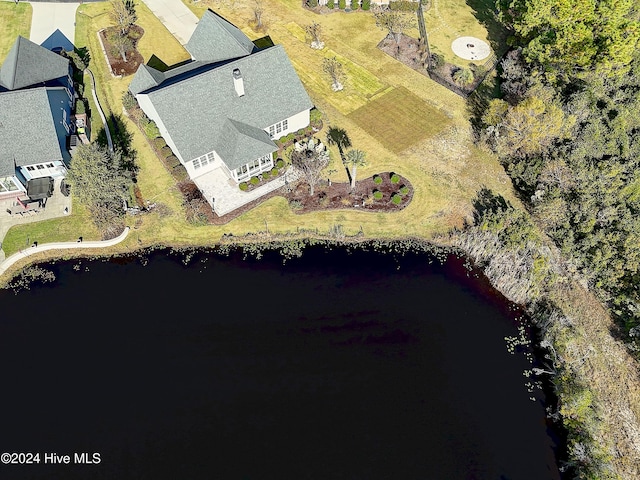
[0,87,62,177]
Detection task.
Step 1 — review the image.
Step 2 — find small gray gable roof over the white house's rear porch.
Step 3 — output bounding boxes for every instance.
[217,119,278,170]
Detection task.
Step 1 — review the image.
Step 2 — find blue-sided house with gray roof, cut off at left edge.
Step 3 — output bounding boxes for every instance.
[0,37,74,199]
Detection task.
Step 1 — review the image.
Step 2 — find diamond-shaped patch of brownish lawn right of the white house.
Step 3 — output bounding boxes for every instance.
[349,87,451,153]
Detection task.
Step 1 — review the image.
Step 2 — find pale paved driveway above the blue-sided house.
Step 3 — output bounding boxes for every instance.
[29,2,80,45]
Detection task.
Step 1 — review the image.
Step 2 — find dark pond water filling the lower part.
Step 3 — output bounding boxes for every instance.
[0,248,560,480]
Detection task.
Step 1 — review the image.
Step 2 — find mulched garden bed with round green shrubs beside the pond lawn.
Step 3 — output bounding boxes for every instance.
[287,172,413,213]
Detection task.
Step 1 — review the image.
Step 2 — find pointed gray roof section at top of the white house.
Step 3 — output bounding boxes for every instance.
[185,10,256,62]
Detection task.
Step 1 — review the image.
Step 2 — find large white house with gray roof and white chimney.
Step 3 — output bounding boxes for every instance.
[129,10,313,213]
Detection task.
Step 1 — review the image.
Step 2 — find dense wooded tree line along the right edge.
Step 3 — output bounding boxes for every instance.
[480,0,640,350]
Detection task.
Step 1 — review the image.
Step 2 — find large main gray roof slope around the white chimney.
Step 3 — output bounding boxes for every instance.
[142,45,313,168]
